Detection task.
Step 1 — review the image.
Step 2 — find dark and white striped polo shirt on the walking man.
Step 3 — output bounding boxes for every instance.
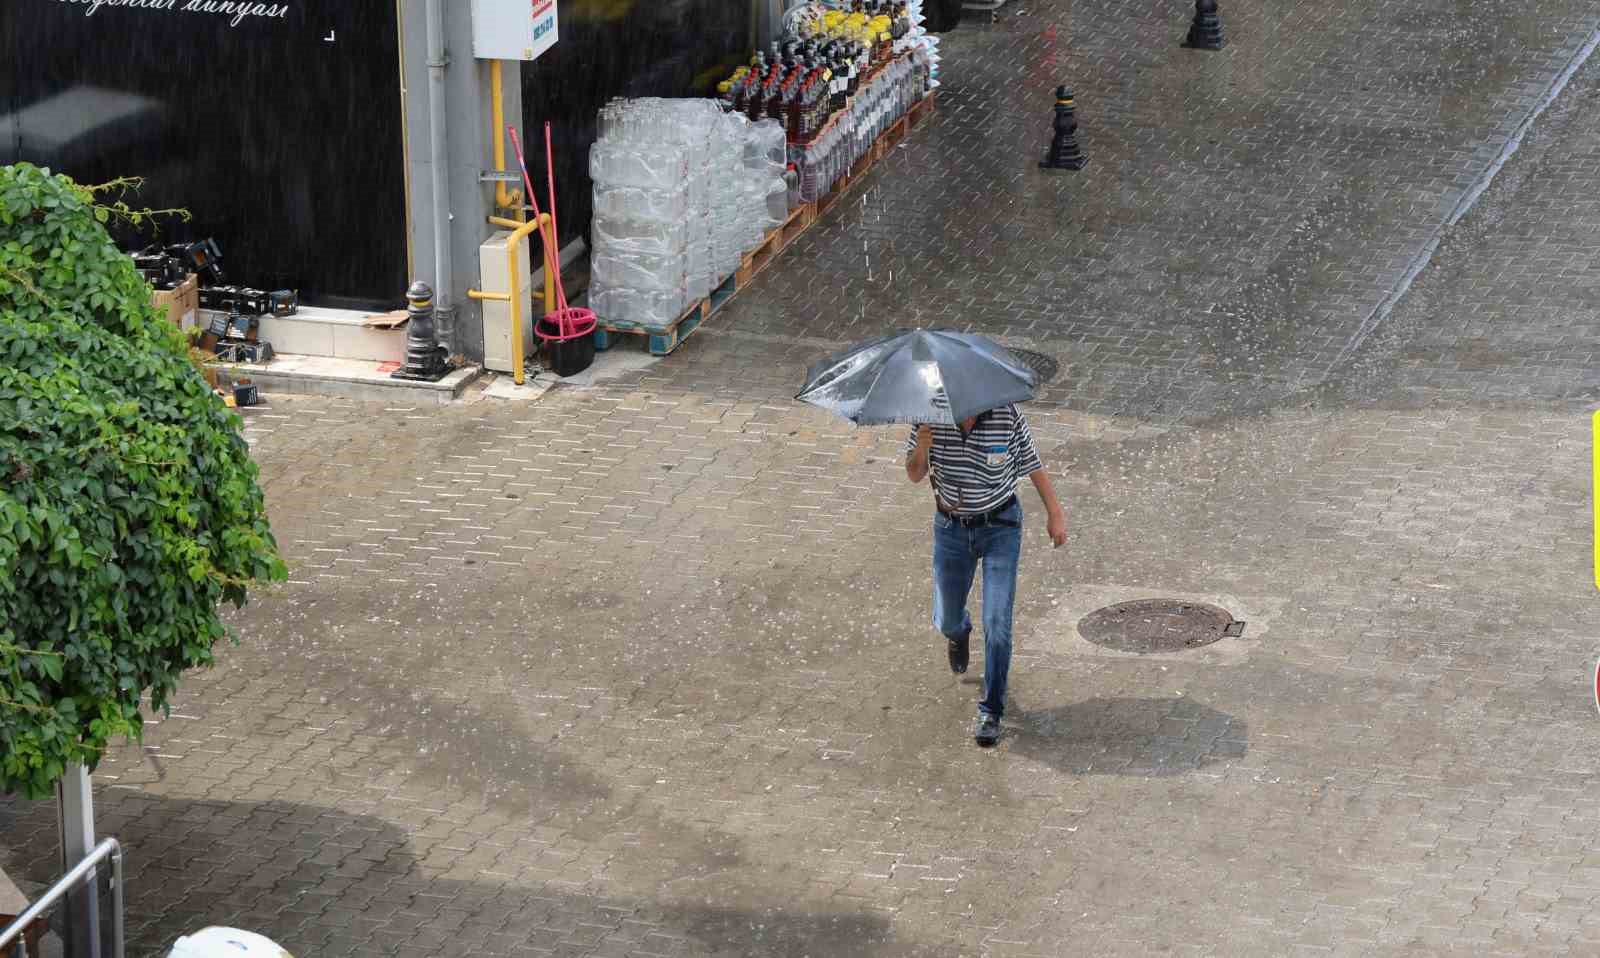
[906,405,1045,515]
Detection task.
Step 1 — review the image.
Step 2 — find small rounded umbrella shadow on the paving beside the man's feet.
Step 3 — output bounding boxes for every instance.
[1010,696,1250,777]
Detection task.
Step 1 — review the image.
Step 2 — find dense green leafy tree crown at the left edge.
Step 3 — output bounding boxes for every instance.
[0,163,285,798]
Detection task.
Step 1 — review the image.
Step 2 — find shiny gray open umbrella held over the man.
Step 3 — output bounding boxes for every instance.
[795,329,1038,425]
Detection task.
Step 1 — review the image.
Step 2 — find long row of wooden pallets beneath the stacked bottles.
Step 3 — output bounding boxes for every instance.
[595,93,933,357]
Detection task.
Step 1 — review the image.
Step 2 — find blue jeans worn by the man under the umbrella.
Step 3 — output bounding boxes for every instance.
[933,502,1022,718]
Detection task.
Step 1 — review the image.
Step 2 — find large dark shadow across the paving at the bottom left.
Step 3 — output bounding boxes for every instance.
[0,790,942,958]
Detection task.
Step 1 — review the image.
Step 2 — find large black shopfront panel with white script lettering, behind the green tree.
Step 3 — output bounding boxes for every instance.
[0,0,412,307]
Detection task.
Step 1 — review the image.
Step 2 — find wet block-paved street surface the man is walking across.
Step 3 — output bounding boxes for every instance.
[0,0,1600,958]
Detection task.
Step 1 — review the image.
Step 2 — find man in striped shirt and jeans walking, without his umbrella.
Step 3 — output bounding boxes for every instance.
[906,405,1067,747]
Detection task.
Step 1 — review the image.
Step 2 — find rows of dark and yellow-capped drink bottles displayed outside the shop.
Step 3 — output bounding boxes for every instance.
[718,0,939,203]
